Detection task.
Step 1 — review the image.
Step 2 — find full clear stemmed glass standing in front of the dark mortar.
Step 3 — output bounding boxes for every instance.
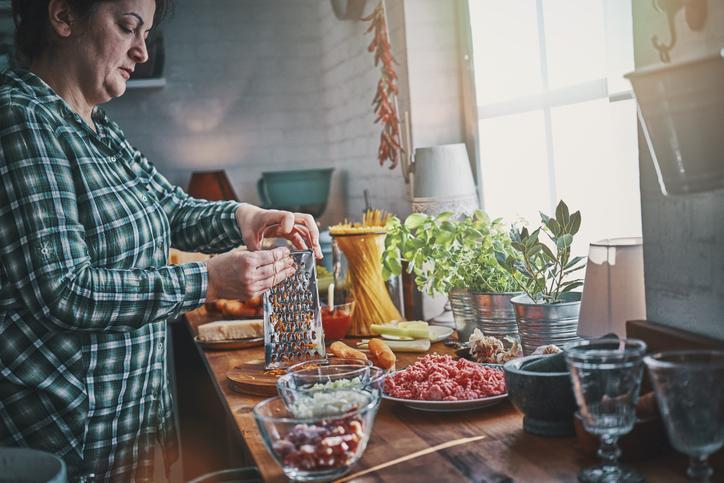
[565,338,646,482]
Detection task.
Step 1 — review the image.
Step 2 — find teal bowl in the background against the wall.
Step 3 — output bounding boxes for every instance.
[256,168,334,217]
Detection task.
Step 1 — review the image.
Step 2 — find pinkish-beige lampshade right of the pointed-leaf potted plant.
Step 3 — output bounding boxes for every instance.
[578,238,646,337]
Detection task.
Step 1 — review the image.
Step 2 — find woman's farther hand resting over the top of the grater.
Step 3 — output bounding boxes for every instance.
[236,203,322,259]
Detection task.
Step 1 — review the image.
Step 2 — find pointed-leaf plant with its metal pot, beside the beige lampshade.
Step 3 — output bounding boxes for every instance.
[496,201,586,355]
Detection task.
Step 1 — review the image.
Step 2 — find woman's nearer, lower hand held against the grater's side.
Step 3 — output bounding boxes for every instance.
[206,247,296,301]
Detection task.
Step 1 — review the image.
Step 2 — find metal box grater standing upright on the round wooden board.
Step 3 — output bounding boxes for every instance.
[264,250,325,369]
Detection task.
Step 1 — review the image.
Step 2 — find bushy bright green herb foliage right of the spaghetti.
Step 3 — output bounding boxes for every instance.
[382,210,517,294]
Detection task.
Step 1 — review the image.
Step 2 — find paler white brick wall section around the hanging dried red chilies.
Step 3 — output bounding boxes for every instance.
[319,0,410,219]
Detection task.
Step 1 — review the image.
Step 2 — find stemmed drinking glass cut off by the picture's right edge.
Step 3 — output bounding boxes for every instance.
[644,350,724,481]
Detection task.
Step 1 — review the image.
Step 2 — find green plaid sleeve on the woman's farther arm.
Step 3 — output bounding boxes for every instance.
[129,150,243,253]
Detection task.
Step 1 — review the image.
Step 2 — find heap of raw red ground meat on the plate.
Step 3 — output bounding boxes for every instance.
[385,354,506,401]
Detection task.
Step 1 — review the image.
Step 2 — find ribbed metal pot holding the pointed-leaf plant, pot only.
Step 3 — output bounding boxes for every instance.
[510,293,581,356]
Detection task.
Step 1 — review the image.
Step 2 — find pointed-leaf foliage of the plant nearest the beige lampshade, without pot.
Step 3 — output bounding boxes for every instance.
[495,201,586,304]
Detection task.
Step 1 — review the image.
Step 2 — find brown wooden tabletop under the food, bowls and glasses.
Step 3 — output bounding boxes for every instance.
[182,310,724,482]
